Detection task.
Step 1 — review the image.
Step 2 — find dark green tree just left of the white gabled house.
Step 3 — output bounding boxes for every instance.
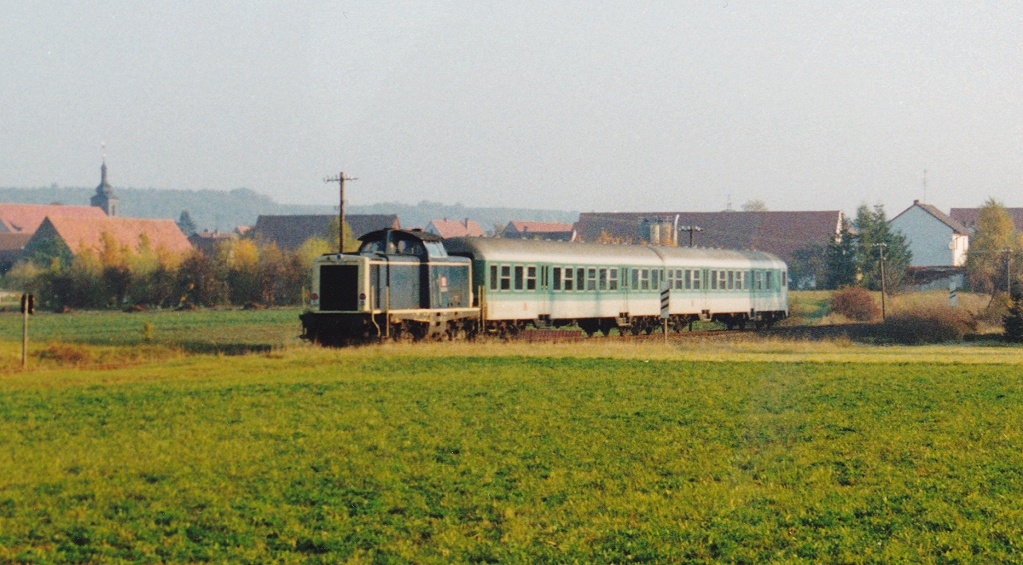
[852,204,913,292]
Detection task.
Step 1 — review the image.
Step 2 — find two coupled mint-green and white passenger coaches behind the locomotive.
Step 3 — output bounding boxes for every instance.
[444,237,789,335]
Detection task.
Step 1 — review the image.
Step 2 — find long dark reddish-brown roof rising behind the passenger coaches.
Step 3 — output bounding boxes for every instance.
[576,210,842,261]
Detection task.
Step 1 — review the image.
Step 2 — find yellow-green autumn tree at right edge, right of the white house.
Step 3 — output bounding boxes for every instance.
[966,199,1023,293]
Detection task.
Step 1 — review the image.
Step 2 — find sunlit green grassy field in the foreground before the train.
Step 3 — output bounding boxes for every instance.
[0,329,1023,563]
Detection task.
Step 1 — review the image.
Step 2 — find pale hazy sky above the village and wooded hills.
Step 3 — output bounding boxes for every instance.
[0,0,1023,216]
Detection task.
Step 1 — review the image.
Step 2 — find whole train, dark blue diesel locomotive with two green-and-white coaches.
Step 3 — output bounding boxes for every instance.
[300,229,789,345]
